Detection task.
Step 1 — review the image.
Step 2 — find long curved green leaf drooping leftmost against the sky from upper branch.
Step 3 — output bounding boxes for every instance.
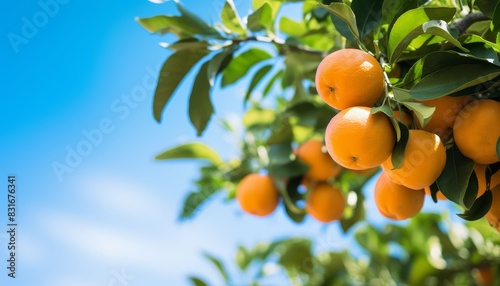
[153,45,208,122]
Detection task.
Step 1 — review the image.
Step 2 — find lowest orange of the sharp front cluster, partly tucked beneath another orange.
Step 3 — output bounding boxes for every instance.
[375,172,425,220]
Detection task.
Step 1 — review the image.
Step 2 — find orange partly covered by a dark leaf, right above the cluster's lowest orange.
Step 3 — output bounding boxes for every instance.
[382,130,446,190]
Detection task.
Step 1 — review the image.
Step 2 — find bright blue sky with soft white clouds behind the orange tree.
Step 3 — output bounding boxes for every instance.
[0,0,454,286]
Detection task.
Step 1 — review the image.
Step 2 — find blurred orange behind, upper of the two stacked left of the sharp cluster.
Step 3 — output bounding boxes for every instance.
[294,140,342,181]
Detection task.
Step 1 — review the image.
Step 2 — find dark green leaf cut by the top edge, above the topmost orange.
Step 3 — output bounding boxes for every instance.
[351,0,384,39]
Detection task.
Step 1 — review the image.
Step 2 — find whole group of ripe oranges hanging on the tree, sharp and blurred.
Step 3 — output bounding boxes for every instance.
[236,49,500,229]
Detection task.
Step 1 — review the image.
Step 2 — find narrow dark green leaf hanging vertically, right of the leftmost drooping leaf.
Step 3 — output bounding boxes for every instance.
[189,61,214,136]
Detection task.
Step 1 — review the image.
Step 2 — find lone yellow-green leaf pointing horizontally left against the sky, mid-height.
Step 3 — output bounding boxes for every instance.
[155,142,223,166]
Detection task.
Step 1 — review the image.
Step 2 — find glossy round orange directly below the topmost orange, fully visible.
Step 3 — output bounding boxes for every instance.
[325,106,396,170]
